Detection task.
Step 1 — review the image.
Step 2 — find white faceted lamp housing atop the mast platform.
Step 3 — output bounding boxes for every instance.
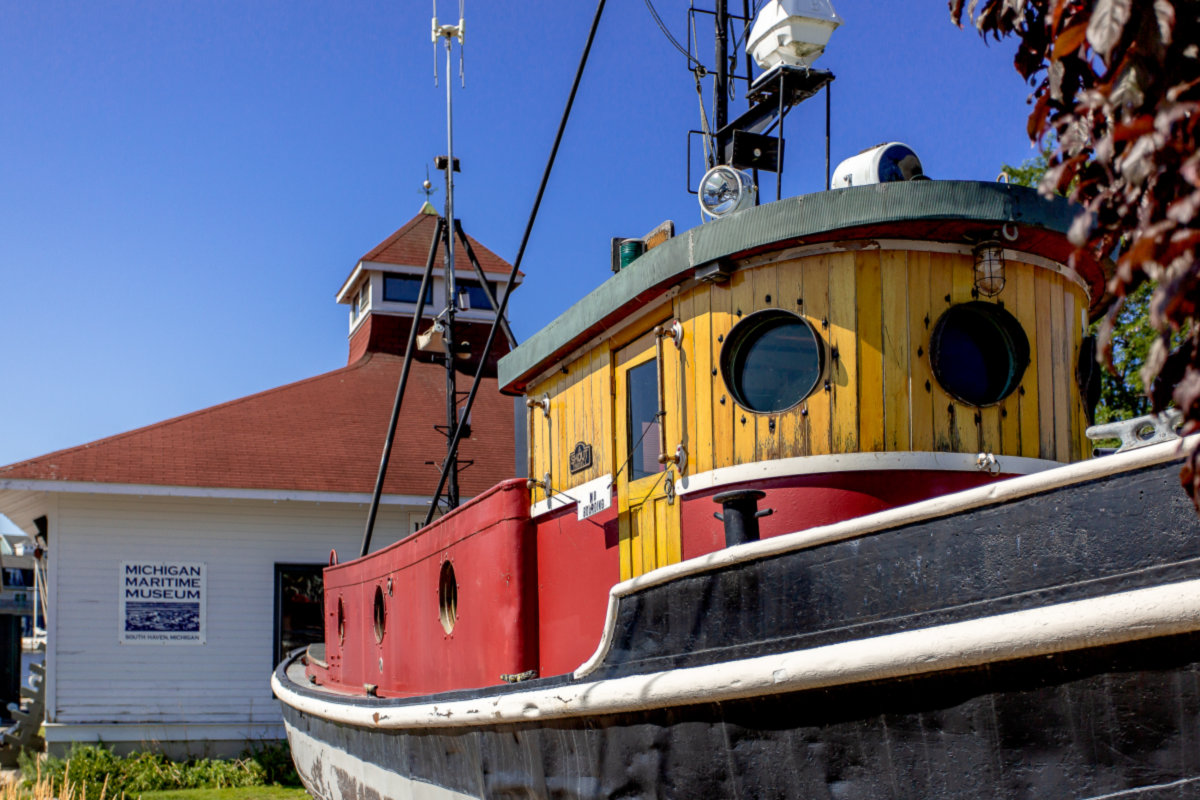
[746,0,842,70]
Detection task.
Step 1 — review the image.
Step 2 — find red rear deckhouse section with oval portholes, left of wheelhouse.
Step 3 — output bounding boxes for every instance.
[314,480,538,696]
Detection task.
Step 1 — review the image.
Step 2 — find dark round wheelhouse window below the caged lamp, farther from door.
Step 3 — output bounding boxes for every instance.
[929,302,1030,405]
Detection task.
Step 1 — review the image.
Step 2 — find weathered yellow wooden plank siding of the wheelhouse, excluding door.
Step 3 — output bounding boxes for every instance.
[530,248,1088,510]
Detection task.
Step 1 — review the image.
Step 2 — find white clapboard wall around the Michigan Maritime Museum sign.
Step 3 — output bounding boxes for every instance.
[47,494,418,724]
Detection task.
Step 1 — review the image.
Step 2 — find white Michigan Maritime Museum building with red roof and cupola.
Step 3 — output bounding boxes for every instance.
[0,204,515,756]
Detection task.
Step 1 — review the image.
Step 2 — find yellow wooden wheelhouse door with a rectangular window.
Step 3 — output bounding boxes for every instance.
[614,331,680,581]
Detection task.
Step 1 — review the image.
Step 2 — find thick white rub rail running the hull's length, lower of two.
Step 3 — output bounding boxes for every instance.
[271,579,1200,729]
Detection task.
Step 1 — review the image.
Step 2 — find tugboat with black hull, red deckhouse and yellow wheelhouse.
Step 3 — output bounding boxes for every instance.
[272,0,1200,800]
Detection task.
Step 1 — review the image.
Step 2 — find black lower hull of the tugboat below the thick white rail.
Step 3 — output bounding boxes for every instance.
[284,634,1200,800]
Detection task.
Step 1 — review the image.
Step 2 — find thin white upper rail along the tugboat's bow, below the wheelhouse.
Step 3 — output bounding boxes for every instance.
[575,434,1200,678]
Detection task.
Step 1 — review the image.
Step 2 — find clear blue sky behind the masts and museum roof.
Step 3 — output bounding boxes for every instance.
[0,0,1032,482]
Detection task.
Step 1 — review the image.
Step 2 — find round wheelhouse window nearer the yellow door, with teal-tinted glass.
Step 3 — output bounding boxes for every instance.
[721,308,824,414]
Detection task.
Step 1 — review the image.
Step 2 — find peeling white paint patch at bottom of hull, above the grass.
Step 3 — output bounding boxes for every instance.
[284,723,475,800]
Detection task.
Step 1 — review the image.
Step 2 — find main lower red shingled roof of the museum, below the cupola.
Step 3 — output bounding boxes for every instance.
[0,353,514,497]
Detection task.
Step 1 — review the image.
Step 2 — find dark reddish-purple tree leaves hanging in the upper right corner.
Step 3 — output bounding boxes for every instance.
[949,0,1200,496]
